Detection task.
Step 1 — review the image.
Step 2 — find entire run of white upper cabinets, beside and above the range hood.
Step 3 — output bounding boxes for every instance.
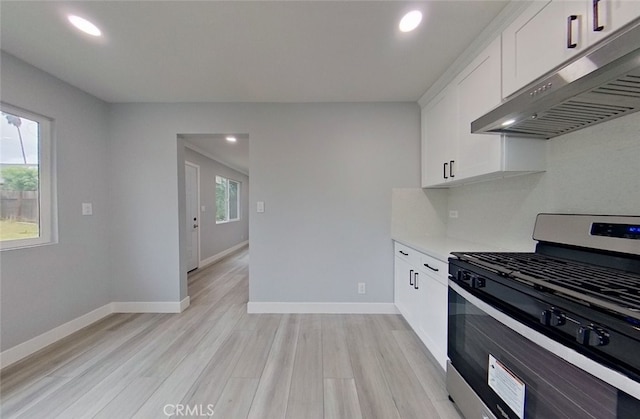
[421,0,640,188]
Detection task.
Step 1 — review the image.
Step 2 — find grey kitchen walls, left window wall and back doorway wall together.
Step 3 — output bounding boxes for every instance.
[1,53,420,350]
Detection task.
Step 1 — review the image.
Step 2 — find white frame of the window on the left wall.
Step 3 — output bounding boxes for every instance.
[0,102,57,251]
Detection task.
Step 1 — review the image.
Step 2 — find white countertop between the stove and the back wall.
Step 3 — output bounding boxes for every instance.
[391,235,510,262]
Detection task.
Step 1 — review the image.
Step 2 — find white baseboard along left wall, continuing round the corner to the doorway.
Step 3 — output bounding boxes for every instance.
[0,296,191,369]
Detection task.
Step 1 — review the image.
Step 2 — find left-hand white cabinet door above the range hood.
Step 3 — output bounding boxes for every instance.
[502,0,588,97]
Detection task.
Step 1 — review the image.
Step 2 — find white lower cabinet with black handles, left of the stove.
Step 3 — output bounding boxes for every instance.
[394,242,448,370]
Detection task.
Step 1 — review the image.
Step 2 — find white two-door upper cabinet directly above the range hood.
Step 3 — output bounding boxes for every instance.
[502,0,640,97]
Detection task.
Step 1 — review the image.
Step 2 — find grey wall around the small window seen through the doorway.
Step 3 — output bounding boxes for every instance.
[184,148,250,261]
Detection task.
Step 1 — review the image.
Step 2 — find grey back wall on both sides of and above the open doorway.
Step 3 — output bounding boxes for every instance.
[109,103,420,302]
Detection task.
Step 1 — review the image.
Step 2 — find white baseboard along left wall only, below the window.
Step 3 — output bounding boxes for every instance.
[0,303,113,368]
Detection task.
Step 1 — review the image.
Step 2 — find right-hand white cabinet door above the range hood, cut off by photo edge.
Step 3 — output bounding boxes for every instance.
[586,0,640,44]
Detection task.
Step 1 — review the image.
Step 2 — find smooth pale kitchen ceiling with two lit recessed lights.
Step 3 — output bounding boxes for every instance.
[0,0,508,174]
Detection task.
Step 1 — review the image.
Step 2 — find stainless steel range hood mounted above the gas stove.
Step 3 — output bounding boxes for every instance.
[471,20,640,139]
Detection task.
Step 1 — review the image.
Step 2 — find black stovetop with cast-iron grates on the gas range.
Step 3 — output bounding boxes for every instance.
[452,252,640,320]
